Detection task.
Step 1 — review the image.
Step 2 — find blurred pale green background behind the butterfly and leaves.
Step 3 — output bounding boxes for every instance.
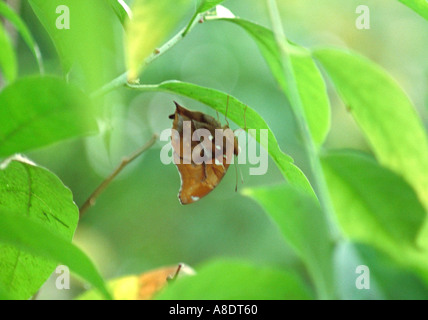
[2,0,428,299]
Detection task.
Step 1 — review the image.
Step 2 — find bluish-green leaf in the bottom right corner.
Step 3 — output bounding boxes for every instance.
[335,242,428,300]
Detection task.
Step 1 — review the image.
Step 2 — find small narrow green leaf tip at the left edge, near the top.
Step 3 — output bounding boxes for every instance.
[0,22,18,82]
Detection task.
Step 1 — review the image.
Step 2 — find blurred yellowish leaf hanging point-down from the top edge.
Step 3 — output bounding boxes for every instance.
[125,0,193,80]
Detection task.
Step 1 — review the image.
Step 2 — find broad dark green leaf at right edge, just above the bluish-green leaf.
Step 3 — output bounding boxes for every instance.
[322,152,425,248]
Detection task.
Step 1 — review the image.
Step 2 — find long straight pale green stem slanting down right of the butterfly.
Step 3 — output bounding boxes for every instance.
[267,0,340,298]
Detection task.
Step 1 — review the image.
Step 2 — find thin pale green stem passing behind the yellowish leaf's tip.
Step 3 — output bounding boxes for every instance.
[91,14,205,98]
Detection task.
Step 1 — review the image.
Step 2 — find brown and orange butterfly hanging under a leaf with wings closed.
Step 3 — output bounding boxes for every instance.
[169,102,239,204]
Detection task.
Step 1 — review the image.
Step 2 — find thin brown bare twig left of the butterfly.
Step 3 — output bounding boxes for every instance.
[79,134,158,218]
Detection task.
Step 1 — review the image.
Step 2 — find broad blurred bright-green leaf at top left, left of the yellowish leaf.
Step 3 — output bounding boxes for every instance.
[29,0,117,92]
